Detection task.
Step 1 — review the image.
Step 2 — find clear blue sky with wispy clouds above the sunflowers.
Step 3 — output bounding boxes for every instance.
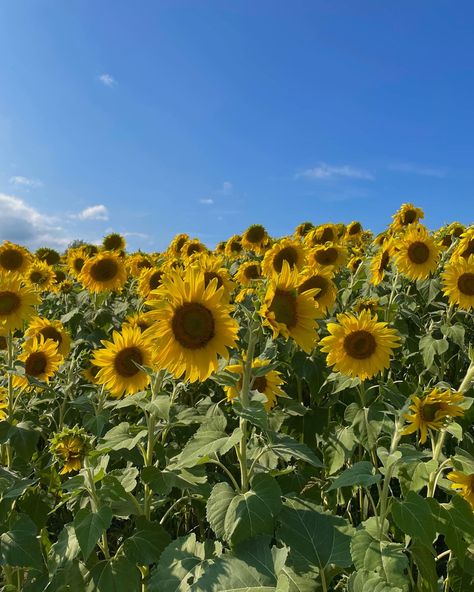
[0,0,474,250]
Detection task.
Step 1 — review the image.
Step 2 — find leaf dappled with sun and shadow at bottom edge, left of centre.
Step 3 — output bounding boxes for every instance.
[148,533,222,592]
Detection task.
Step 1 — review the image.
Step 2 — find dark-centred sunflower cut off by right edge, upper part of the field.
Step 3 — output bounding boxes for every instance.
[441,255,474,310]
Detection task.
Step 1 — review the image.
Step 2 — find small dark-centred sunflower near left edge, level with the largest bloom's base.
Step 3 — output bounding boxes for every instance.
[13,335,64,389]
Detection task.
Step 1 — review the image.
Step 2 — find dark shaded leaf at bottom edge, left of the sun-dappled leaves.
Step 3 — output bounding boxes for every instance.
[86,557,141,592]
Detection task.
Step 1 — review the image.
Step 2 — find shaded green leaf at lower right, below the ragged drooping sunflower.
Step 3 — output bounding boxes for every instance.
[392,491,436,547]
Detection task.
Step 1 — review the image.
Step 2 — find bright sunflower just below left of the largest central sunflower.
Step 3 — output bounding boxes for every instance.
[92,325,155,398]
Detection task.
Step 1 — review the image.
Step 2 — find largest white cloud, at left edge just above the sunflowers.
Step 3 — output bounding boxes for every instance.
[0,193,71,248]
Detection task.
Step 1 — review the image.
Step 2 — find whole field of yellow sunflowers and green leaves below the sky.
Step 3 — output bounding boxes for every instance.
[0,204,474,592]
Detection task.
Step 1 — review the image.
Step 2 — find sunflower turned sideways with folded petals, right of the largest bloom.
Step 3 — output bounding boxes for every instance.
[259,261,319,353]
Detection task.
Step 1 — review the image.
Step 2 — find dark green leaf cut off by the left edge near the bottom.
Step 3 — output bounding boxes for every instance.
[0,514,44,570]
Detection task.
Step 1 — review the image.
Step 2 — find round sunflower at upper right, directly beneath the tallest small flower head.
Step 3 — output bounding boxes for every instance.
[395,224,439,280]
